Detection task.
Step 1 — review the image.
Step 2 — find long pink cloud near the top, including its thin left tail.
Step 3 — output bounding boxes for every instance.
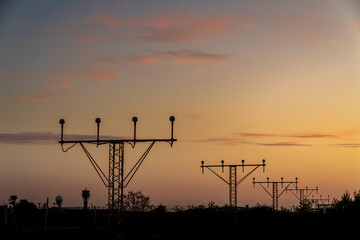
[86,11,252,43]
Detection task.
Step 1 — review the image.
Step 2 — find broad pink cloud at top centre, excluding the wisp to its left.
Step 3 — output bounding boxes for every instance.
[130,12,252,42]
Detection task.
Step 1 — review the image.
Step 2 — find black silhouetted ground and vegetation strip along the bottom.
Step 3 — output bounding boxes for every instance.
[0,206,360,240]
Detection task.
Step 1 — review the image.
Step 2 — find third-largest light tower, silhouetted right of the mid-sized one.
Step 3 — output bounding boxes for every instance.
[253,178,298,210]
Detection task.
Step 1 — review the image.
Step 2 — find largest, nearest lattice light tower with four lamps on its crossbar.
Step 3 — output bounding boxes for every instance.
[59,116,177,238]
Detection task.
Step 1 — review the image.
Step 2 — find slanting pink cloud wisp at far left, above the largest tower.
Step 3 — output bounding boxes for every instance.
[7,77,73,102]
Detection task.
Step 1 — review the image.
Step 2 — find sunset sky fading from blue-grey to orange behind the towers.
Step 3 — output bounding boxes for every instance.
[0,0,360,207]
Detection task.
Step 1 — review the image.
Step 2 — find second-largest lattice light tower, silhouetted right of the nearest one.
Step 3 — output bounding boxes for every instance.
[200,160,266,207]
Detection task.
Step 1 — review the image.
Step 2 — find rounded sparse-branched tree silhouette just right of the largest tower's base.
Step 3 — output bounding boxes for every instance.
[124,191,151,212]
